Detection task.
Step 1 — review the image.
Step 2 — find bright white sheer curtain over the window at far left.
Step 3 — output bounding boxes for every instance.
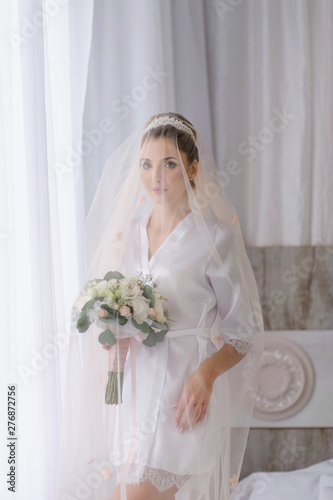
[0,0,92,500]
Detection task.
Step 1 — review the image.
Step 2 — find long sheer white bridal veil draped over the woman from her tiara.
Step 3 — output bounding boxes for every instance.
[56,113,263,500]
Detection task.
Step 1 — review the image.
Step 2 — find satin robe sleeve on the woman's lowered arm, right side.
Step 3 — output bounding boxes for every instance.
[206,223,255,354]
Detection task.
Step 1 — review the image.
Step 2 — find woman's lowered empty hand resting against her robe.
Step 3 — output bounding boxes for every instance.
[174,365,215,432]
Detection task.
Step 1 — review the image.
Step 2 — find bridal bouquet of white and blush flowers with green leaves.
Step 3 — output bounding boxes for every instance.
[76,271,168,404]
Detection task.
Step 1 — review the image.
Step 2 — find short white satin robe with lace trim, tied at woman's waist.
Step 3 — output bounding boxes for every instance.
[110,213,250,499]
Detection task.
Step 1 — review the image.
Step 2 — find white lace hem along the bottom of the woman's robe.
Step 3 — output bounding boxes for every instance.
[125,464,191,491]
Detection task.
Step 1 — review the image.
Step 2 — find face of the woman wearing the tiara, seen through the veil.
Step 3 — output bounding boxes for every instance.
[140,137,193,204]
